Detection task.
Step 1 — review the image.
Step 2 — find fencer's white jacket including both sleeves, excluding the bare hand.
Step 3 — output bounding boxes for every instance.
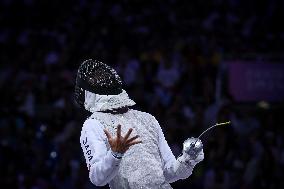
[80,109,203,189]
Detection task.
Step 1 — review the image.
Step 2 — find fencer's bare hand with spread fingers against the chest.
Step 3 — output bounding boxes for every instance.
[104,125,142,153]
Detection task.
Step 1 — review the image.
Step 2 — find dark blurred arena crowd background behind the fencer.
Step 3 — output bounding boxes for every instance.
[0,0,284,189]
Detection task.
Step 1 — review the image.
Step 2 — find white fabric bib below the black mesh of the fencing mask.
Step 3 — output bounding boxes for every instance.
[84,90,135,113]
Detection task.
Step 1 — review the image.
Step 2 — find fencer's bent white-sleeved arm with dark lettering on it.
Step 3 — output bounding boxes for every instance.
[80,119,121,186]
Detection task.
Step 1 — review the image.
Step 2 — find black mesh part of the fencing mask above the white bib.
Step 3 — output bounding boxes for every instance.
[75,59,122,106]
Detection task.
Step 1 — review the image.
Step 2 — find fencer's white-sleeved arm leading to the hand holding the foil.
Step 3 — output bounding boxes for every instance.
[155,122,203,183]
